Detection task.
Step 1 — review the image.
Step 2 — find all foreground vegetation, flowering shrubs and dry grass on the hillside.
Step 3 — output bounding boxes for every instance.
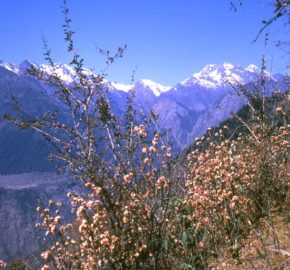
[3,84,290,269]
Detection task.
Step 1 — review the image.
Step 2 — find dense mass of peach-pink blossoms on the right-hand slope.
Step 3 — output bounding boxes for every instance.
[182,118,290,268]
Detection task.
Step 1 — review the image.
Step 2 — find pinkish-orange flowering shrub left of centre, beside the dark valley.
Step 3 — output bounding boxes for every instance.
[32,130,184,269]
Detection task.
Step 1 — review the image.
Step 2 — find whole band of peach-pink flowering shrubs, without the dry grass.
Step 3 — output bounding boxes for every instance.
[28,116,290,269]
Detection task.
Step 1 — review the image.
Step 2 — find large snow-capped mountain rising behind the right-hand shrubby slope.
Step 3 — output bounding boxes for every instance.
[155,63,287,148]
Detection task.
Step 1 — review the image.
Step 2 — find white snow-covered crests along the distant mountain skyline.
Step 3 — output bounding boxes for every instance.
[0,60,281,96]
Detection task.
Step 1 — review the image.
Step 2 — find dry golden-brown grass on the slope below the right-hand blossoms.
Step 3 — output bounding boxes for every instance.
[210,214,290,270]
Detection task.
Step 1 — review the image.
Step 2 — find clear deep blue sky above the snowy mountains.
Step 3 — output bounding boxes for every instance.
[0,0,287,85]
